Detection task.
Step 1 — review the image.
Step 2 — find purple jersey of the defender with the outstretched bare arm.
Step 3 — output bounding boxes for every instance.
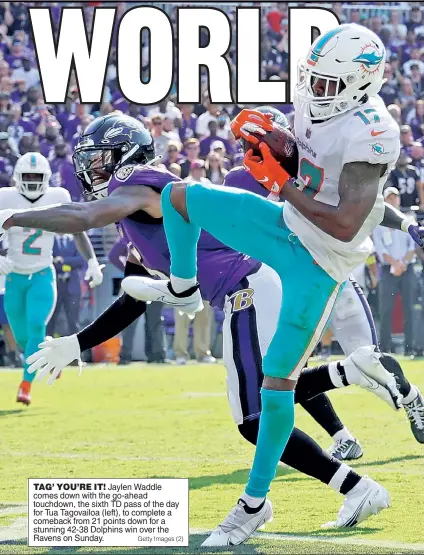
[109,165,261,308]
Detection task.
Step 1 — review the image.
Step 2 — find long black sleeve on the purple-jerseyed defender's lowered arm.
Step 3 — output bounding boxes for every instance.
[77,262,150,351]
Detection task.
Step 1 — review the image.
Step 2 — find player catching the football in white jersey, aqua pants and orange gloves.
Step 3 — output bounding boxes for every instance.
[102,25,400,547]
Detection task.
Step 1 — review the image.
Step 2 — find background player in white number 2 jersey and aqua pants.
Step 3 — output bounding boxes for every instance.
[0,152,103,405]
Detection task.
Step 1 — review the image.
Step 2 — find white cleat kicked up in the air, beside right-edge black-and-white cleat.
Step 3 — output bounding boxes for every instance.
[341,345,402,410]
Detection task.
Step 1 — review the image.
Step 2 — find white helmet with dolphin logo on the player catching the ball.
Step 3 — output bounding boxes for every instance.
[295,23,386,120]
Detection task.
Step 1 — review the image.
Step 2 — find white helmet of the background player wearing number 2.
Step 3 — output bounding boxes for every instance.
[13,152,52,199]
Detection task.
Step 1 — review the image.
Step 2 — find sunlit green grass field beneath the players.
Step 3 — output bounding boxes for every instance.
[0,361,424,554]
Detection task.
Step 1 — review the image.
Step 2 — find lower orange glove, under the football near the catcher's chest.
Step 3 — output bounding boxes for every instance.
[243,143,290,195]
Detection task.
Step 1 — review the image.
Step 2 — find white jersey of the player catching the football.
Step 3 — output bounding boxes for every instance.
[284,96,400,283]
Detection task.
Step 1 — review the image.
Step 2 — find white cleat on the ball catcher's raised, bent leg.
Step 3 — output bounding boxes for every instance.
[121,276,203,314]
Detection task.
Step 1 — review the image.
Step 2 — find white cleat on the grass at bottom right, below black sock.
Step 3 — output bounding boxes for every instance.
[322,476,390,528]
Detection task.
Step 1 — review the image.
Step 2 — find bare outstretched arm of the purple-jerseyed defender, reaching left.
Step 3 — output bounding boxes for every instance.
[3,185,162,233]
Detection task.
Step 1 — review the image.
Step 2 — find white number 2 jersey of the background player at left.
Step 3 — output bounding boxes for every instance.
[0,187,72,274]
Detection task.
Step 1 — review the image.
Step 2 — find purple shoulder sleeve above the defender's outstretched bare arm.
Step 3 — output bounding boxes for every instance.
[109,165,181,194]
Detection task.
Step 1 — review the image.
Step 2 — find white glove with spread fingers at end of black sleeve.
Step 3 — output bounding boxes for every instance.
[26,334,82,385]
